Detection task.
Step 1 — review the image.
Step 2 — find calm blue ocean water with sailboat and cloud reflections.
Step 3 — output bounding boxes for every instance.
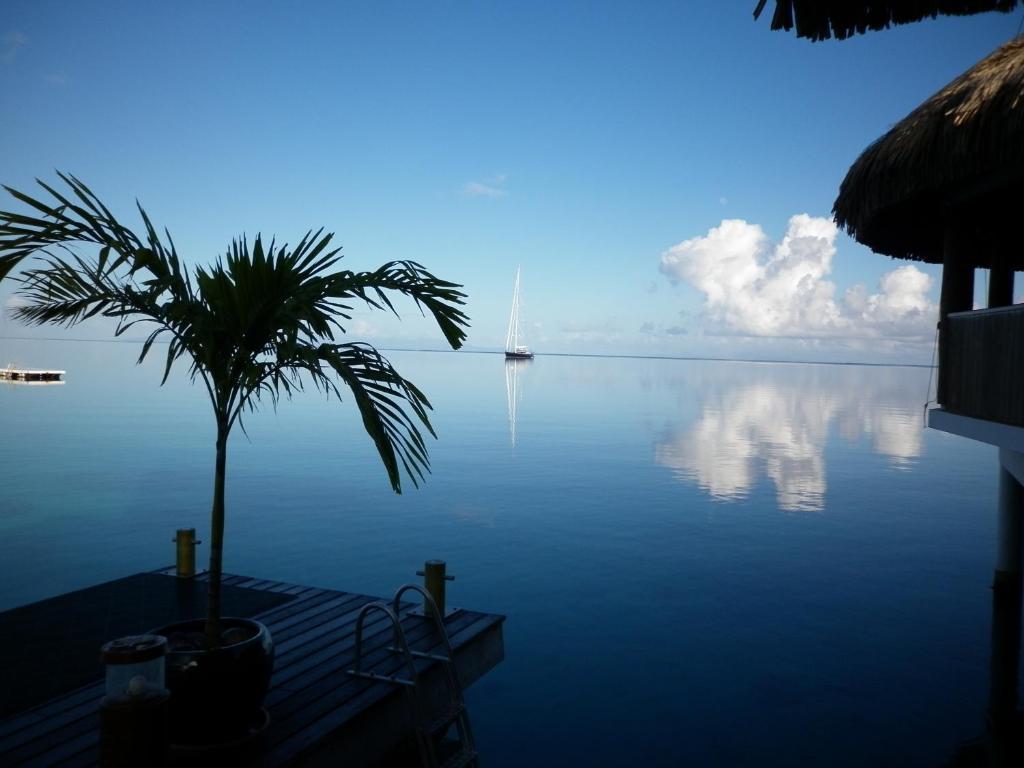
[0,341,996,766]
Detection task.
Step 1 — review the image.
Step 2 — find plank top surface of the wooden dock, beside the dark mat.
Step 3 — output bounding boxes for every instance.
[0,568,504,766]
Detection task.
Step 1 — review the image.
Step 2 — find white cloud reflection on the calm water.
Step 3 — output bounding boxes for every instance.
[654,366,924,512]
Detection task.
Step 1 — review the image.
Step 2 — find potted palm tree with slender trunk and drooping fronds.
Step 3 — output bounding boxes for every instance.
[0,174,468,646]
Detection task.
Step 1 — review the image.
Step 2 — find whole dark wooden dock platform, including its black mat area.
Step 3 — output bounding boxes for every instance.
[0,567,505,768]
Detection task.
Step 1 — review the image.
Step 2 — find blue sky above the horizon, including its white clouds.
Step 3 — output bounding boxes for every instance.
[0,0,1024,362]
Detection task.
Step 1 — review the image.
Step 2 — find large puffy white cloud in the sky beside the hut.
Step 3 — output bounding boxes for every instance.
[660,214,937,339]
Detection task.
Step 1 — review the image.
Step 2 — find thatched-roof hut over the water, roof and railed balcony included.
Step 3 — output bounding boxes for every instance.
[833,37,1024,411]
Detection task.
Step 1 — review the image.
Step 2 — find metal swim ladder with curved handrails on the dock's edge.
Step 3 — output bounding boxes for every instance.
[348,584,478,768]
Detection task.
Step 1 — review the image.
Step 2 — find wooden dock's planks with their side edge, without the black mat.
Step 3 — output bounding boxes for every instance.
[0,568,505,768]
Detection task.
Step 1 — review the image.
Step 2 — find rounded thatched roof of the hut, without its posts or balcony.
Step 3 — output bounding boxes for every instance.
[833,36,1024,269]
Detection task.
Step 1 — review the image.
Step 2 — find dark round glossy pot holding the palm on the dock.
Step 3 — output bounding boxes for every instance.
[155,617,273,744]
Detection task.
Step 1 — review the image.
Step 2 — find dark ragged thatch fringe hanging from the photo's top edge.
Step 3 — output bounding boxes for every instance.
[754,0,1020,40]
